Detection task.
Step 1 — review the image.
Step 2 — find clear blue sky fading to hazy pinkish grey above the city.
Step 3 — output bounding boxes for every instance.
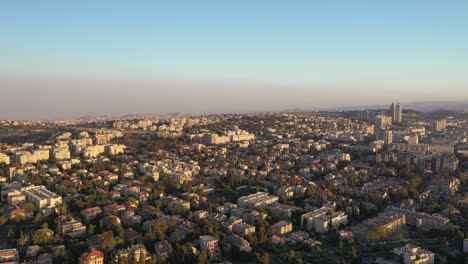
[0,0,468,119]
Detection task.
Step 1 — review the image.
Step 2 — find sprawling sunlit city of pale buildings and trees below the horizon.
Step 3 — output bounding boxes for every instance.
[0,103,468,264]
